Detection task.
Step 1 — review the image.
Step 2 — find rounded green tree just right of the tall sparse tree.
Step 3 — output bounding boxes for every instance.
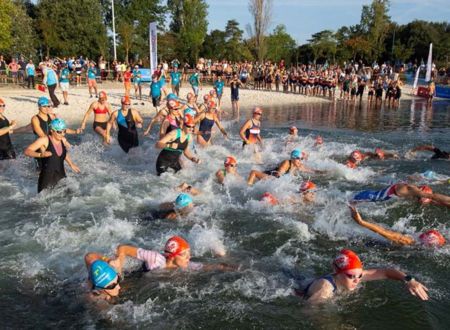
[267,24,296,64]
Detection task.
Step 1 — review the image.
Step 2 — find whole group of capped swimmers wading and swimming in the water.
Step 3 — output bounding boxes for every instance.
[0,85,450,303]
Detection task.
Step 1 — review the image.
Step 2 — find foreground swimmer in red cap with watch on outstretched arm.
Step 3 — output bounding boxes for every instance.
[297,249,428,304]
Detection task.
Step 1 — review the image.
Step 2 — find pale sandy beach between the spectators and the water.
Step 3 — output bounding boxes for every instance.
[0,82,417,127]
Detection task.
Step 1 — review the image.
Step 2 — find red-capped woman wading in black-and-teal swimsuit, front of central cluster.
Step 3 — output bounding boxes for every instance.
[155,115,200,176]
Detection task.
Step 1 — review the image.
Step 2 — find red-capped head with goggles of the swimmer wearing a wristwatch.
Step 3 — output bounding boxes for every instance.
[333,249,363,291]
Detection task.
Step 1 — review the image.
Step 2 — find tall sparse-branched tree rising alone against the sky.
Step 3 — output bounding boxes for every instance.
[247,0,272,62]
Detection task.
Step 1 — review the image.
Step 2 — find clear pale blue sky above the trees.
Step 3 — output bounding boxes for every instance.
[206,0,450,44]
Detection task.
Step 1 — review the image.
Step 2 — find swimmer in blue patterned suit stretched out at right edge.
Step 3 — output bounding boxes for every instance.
[350,183,450,207]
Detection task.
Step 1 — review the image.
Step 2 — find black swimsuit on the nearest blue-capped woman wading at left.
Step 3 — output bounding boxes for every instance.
[38,138,67,193]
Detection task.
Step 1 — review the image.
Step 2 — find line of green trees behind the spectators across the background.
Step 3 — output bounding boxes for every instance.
[0,0,450,66]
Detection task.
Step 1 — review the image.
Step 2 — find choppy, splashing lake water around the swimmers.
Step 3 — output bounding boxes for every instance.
[0,102,450,329]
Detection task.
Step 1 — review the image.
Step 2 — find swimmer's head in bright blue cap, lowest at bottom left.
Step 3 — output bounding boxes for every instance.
[89,260,120,296]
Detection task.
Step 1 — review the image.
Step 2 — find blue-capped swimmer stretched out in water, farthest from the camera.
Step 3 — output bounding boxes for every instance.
[247,149,324,185]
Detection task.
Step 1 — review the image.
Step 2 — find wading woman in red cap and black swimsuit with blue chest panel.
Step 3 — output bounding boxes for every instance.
[105,96,143,153]
